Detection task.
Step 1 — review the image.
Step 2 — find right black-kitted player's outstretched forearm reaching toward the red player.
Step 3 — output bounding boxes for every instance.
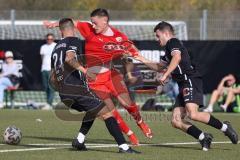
[133,54,167,72]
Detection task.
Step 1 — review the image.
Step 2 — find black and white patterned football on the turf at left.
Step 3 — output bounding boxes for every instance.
[3,126,22,145]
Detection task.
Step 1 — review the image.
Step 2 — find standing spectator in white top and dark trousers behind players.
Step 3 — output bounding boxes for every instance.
[40,33,56,109]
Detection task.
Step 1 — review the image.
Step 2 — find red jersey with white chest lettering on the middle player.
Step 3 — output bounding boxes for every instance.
[77,21,137,67]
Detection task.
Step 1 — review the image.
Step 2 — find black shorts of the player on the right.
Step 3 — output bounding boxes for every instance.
[174,77,203,108]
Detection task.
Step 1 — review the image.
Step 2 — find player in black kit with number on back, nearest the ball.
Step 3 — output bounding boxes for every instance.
[50,18,139,153]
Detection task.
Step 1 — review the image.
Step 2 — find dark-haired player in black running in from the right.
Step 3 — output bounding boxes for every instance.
[135,21,238,151]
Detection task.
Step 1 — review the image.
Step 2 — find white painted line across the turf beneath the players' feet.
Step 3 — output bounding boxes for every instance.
[0,141,236,153]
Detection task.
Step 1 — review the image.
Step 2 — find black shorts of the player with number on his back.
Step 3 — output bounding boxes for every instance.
[59,86,105,112]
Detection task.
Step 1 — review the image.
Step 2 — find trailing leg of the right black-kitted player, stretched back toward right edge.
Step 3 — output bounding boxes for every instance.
[186,103,238,144]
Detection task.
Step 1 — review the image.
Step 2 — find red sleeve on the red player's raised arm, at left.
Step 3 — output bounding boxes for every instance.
[76,21,94,39]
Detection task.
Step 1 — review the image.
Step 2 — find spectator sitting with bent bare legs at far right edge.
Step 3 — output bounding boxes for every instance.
[203,74,240,112]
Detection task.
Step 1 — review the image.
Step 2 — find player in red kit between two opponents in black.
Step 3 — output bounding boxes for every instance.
[44,8,152,144]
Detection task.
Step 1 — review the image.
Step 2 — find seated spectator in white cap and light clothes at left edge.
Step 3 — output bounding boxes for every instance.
[0,51,19,108]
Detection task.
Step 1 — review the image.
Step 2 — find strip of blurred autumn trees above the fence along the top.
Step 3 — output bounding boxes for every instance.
[0,0,240,11]
